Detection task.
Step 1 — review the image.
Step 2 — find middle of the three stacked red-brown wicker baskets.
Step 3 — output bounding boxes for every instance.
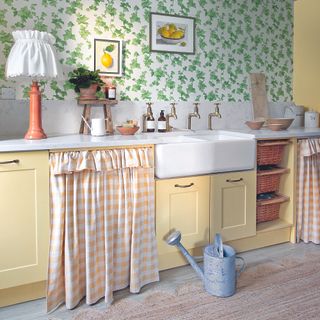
[257,168,289,194]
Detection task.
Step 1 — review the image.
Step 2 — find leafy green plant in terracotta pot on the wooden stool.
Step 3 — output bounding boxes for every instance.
[68,67,104,99]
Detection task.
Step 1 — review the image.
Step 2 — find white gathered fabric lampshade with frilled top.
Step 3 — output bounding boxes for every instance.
[6,30,62,80]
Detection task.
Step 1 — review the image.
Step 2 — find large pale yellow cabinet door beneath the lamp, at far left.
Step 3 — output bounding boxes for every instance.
[0,151,49,289]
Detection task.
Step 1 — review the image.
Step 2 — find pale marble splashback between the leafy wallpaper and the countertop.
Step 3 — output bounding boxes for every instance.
[0,100,290,139]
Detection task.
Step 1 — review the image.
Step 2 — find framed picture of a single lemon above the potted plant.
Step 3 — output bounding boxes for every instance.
[94,39,122,77]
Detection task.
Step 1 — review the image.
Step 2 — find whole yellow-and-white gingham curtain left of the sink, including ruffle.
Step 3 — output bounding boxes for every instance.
[47,148,159,311]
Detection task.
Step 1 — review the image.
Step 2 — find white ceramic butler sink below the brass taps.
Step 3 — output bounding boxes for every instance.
[155,131,256,178]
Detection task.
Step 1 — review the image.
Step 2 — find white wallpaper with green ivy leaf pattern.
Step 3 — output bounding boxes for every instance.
[0,0,293,101]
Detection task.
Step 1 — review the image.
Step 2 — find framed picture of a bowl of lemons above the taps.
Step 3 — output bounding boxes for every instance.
[149,12,195,54]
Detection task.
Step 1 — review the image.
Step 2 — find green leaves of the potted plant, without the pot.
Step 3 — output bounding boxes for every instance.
[68,67,104,92]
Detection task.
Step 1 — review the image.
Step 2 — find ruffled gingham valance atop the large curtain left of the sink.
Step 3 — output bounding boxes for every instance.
[50,148,153,175]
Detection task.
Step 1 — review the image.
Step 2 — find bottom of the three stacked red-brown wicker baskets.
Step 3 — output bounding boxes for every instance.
[257,194,289,223]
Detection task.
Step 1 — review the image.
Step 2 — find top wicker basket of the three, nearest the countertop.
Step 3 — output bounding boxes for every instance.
[257,140,289,166]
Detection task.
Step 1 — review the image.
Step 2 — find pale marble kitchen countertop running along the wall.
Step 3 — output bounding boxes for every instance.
[0,128,320,152]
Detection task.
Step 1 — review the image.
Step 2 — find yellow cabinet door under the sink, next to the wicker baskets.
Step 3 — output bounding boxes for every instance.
[210,170,256,241]
